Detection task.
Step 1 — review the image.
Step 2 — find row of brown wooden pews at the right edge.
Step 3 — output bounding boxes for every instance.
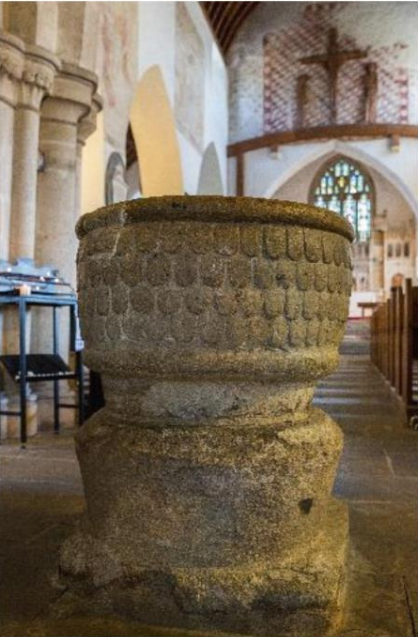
[371,279,418,428]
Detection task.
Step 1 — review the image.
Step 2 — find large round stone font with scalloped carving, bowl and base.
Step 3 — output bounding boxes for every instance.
[61,197,352,637]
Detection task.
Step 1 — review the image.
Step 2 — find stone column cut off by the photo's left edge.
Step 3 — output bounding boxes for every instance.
[0,32,24,259]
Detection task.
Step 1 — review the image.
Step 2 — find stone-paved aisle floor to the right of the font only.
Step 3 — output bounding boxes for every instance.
[315,321,418,637]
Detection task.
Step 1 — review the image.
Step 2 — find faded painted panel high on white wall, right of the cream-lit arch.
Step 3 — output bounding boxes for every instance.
[175,2,205,152]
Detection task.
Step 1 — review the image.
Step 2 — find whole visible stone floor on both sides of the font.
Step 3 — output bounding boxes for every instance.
[0,322,418,637]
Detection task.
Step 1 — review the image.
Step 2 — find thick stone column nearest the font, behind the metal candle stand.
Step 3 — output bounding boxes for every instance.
[32,63,97,354]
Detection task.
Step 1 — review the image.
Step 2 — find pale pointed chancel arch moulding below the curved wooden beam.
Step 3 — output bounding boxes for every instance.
[262,140,418,219]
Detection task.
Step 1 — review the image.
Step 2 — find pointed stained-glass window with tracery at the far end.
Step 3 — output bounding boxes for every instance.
[310,157,373,241]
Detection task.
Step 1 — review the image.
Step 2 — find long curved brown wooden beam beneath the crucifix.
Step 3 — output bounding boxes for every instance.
[228,124,418,157]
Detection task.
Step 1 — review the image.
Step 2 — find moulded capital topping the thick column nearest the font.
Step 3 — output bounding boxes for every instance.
[42,62,98,126]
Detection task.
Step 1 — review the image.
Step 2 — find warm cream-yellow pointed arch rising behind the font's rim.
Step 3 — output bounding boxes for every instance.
[130,65,184,197]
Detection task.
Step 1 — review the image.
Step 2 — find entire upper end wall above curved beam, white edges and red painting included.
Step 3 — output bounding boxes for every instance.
[228,2,418,141]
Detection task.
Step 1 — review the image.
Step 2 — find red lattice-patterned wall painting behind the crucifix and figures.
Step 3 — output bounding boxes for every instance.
[264,3,408,132]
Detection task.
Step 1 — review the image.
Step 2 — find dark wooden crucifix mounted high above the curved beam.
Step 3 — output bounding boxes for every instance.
[300,29,367,124]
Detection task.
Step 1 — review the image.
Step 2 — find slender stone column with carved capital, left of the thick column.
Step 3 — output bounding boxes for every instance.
[10,45,59,259]
